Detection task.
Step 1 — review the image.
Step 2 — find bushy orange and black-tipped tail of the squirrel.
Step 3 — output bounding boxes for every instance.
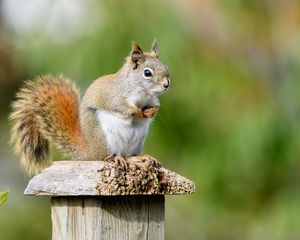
[10,75,85,174]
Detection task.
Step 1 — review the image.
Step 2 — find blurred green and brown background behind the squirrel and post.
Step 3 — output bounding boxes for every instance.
[0,0,300,240]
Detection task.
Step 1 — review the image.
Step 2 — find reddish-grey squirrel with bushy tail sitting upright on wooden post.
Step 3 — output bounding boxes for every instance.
[9,40,170,174]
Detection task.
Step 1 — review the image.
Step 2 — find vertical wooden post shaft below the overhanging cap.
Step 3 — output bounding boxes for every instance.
[51,195,165,240]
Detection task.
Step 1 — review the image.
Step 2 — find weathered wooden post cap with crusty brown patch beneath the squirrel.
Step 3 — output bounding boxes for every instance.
[24,161,195,196]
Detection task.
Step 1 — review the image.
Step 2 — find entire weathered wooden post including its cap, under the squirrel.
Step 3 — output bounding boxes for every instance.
[25,161,195,240]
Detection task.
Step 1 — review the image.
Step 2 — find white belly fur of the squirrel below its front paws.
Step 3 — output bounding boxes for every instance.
[97,110,150,156]
